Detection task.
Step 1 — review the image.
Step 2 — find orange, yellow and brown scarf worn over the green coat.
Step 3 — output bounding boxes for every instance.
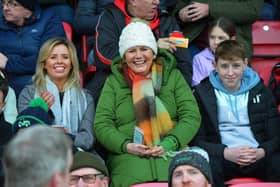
[127,62,174,147]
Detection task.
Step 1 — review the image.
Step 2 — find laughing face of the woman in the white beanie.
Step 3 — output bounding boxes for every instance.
[124,46,155,76]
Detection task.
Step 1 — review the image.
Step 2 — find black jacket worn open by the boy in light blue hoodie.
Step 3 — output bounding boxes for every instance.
[193,78,280,158]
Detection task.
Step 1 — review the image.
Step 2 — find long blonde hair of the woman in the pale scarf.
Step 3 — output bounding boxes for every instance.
[32,38,80,93]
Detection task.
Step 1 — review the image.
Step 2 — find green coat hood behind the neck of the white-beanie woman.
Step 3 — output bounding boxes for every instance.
[111,48,177,85]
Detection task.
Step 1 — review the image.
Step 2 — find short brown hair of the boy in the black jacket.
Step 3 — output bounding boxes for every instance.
[215,40,246,63]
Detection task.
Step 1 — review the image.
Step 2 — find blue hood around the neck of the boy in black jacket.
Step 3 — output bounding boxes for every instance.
[209,67,260,95]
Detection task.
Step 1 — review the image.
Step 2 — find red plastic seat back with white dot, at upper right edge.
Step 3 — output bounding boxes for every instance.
[252,20,280,57]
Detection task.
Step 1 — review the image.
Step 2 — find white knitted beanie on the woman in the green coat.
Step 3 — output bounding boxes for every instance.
[119,21,157,57]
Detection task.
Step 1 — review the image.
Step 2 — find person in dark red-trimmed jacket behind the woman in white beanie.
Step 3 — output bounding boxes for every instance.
[86,0,192,101]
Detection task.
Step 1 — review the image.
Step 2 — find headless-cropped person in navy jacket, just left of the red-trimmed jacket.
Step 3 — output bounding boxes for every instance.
[73,0,114,65]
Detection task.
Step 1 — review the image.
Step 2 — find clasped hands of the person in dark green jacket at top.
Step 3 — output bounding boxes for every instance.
[179,2,209,22]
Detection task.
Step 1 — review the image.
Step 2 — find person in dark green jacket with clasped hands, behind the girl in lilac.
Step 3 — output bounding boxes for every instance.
[175,0,263,57]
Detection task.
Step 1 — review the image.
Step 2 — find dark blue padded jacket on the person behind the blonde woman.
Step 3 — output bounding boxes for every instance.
[0,8,65,95]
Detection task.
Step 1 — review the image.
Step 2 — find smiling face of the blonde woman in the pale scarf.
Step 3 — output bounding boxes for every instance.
[44,44,72,85]
